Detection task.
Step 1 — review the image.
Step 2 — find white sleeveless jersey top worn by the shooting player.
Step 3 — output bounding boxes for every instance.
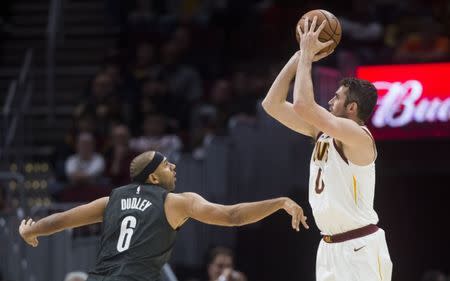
[309,127,378,235]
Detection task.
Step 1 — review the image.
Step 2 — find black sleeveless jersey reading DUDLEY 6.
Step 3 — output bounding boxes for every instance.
[88,184,176,281]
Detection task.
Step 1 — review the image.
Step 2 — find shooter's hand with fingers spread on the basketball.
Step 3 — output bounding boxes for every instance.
[297,16,333,58]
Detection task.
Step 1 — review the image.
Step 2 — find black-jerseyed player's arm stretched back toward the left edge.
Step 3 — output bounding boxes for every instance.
[19,197,109,247]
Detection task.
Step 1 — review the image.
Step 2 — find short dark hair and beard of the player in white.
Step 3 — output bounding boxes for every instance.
[339,77,378,122]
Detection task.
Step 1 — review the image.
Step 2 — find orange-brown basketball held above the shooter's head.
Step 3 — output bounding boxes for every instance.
[295,10,342,53]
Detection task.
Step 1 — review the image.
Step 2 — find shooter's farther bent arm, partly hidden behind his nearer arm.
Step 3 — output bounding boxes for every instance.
[262,52,331,137]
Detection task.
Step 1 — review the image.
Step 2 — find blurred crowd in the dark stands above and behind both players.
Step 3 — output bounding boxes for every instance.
[43,0,450,201]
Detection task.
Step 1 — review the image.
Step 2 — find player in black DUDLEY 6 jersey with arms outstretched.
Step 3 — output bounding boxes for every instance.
[19,151,308,281]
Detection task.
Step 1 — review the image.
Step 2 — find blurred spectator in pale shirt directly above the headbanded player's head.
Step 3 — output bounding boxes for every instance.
[130,113,183,162]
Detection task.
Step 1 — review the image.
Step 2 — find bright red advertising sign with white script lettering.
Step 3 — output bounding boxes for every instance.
[357,63,450,139]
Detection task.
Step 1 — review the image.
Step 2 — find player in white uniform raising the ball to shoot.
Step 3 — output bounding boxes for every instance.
[263,17,392,281]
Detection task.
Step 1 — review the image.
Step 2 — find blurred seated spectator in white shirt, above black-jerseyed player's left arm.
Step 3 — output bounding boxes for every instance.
[65,133,105,186]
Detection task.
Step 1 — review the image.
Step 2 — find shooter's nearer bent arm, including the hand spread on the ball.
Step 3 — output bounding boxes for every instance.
[294,17,371,146]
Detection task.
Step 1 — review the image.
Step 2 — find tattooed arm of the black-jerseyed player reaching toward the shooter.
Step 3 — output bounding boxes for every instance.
[165,192,308,231]
